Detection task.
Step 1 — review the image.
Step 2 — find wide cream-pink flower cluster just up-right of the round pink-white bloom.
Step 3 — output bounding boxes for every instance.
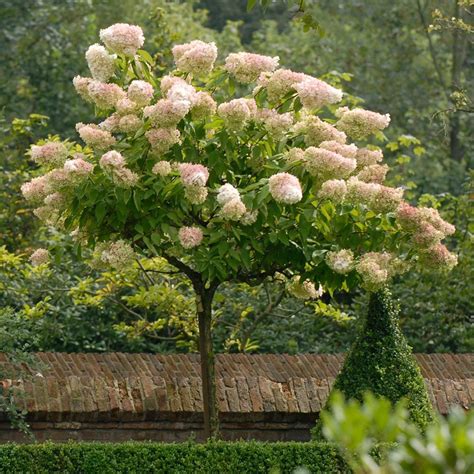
[303,147,357,181]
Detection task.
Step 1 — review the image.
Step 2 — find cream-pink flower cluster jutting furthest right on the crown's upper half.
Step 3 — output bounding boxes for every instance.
[336,107,390,140]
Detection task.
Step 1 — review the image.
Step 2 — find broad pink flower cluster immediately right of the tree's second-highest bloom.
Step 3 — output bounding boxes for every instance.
[224,52,279,84]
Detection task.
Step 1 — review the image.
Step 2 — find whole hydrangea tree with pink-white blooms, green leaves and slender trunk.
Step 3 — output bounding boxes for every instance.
[22,24,456,436]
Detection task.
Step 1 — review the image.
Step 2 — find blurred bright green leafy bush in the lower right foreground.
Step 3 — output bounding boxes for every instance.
[321,392,474,474]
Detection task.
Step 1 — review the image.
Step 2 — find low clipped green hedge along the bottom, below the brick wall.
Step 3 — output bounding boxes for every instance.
[0,441,349,474]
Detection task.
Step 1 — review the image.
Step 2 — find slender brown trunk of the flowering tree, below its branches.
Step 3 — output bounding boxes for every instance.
[195,287,219,439]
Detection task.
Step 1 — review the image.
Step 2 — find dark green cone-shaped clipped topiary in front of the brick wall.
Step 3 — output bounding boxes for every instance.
[314,289,434,436]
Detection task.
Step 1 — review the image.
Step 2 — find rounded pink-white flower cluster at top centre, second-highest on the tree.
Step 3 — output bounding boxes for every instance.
[172,40,217,76]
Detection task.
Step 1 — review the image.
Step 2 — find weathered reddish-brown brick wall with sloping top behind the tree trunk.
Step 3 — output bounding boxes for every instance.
[0,353,474,442]
